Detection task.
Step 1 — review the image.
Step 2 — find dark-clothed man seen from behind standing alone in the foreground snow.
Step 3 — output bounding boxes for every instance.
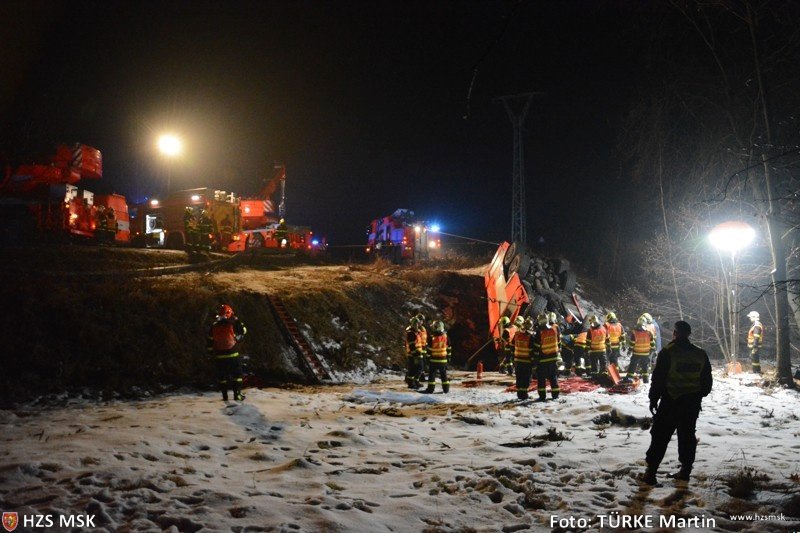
[642,320,713,485]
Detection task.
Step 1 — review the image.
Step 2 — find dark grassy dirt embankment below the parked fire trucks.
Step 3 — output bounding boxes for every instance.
[0,247,486,404]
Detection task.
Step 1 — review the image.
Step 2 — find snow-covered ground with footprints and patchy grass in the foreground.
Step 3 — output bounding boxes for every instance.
[0,373,800,532]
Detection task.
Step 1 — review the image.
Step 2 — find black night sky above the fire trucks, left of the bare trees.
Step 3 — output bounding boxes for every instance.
[0,0,663,248]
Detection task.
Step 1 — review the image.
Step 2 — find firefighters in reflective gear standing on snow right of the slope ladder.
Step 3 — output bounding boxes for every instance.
[405,311,764,401]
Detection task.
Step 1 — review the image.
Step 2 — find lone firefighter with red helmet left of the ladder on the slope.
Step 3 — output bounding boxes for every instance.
[207,304,247,402]
